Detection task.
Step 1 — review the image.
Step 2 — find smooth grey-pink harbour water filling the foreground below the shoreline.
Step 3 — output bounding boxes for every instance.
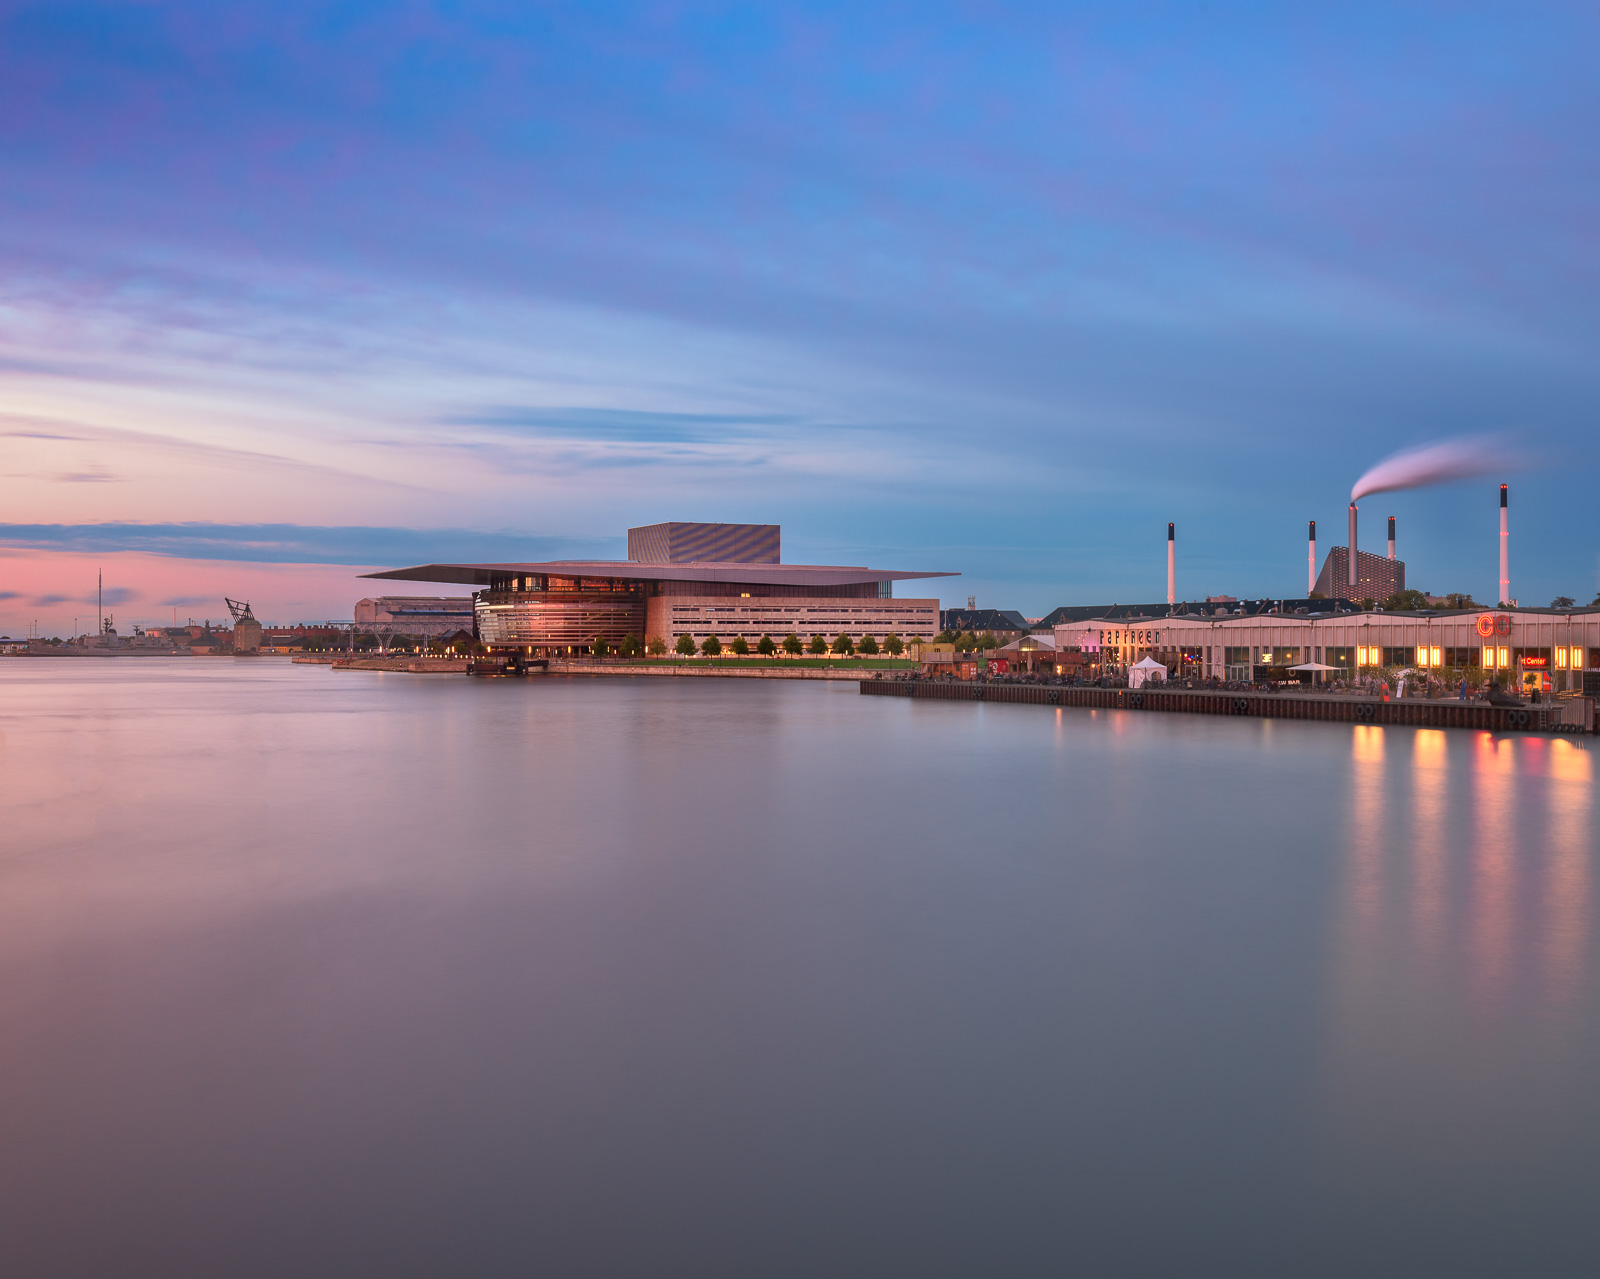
[0,660,1600,1276]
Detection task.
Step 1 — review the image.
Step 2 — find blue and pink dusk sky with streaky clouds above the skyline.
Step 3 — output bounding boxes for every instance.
[0,0,1600,635]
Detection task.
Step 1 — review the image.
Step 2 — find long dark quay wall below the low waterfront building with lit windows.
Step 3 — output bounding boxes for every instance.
[861,679,1595,733]
